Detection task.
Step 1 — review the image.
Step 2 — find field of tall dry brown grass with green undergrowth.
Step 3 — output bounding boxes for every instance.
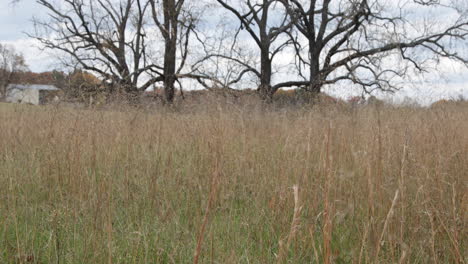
[0,100,468,263]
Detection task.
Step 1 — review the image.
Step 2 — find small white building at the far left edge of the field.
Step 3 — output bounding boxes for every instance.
[6,84,59,105]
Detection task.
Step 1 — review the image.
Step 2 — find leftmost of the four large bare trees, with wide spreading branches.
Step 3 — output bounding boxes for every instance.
[32,0,153,92]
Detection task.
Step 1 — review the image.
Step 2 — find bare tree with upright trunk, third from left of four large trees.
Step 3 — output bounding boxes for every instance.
[217,0,292,100]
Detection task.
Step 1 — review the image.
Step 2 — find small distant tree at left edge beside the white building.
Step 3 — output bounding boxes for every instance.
[0,43,28,101]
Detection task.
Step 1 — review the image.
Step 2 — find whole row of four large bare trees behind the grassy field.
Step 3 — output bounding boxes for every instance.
[20,0,468,102]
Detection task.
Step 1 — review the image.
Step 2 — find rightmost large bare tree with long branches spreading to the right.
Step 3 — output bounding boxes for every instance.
[282,0,468,93]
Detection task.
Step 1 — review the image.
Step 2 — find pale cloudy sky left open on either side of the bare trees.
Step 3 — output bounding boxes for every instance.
[0,0,468,105]
